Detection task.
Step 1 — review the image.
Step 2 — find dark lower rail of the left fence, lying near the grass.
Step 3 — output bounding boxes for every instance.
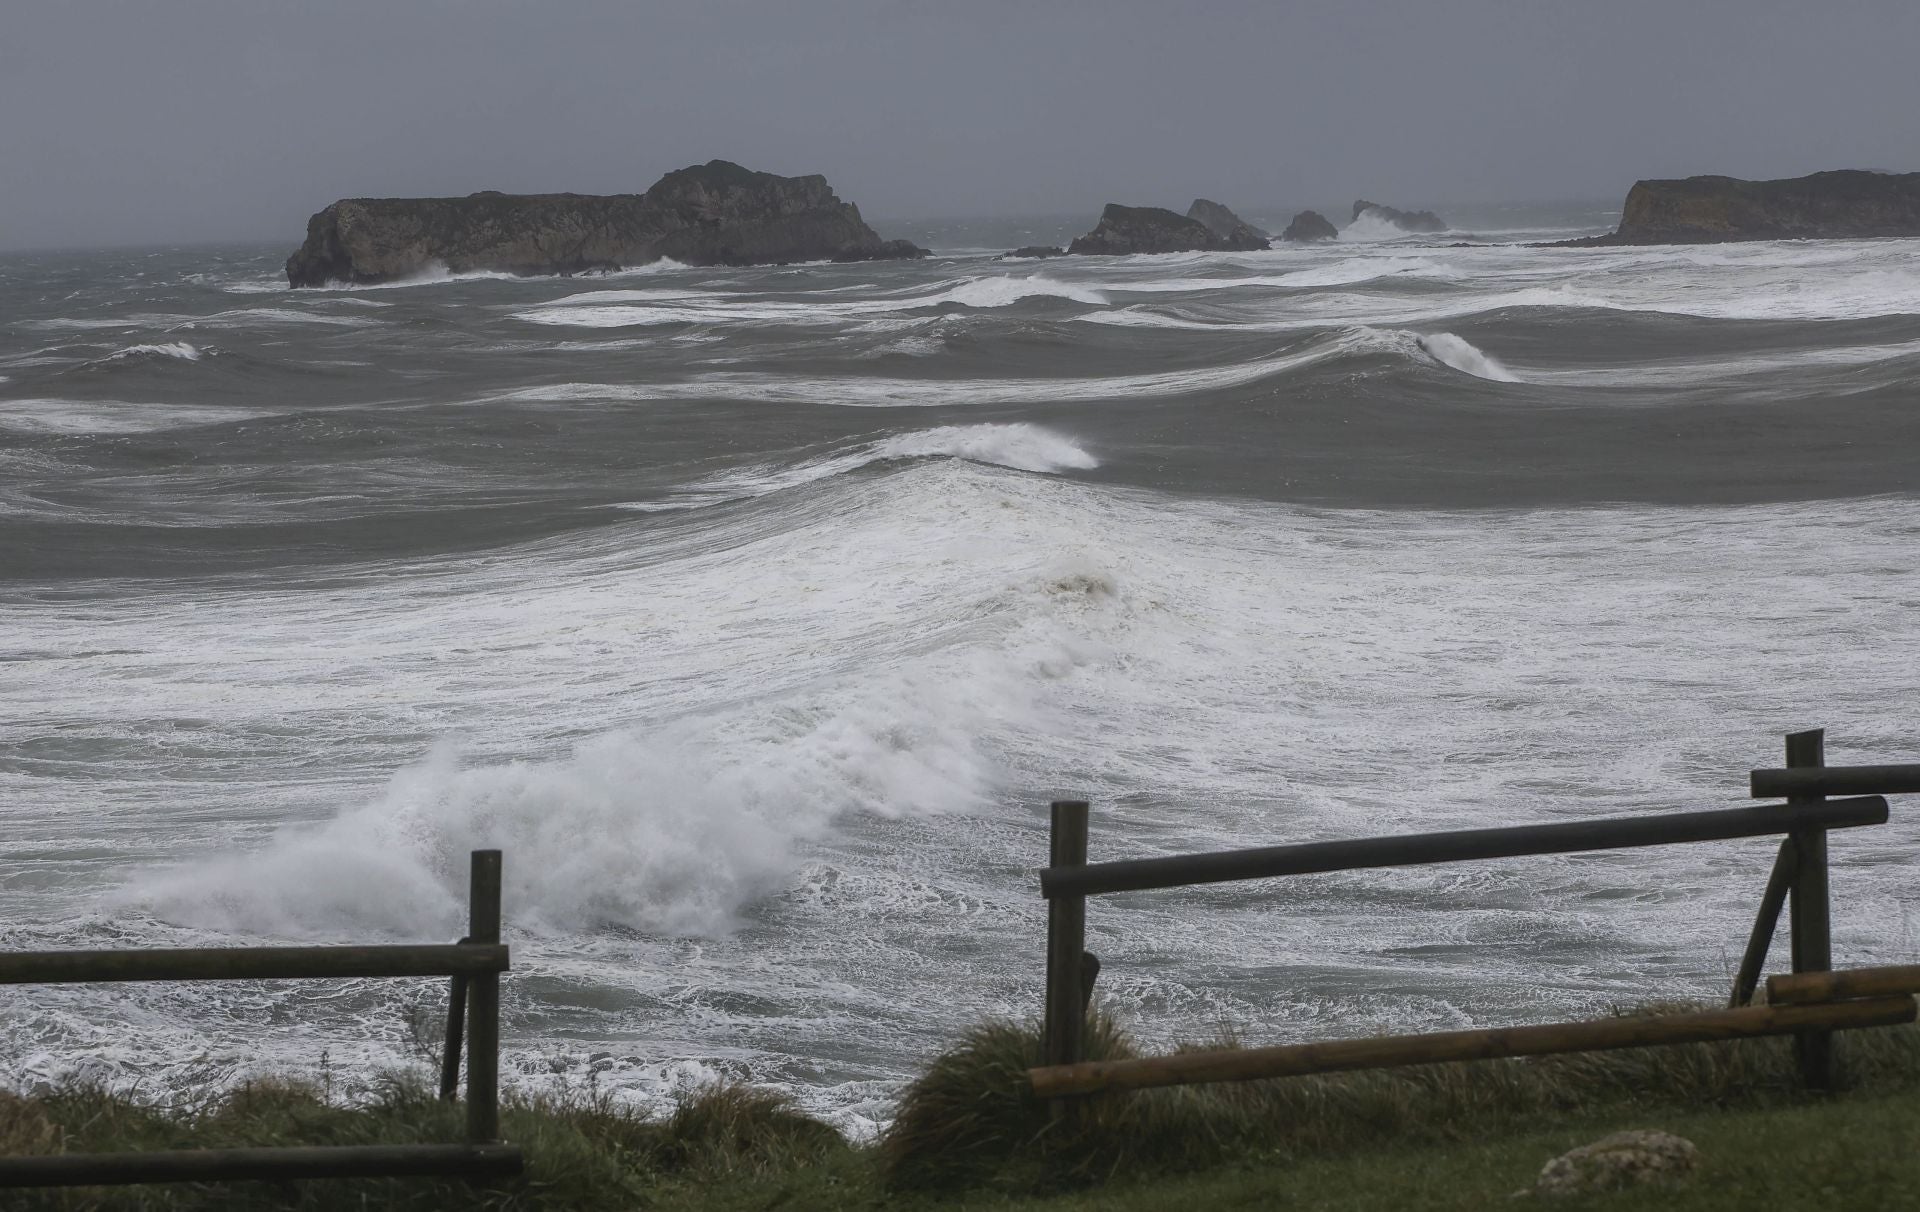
[0,1145,526,1187]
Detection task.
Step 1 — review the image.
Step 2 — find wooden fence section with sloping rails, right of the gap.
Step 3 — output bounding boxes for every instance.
[1029,730,1920,1099]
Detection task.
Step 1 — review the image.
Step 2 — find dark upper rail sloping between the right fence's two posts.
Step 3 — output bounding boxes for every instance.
[1041,795,1887,897]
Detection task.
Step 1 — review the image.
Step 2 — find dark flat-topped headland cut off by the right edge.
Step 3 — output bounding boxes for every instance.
[1571,169,1920,244]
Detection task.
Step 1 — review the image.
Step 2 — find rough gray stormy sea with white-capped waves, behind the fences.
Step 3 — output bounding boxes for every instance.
[0,206,1920,1133]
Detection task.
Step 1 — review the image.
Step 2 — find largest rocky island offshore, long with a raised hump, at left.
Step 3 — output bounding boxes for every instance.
[286,159,927,286]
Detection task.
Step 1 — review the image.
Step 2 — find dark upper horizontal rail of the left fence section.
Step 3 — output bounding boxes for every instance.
[0,943,509,985]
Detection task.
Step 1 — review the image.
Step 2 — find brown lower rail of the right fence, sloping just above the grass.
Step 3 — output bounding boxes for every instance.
[1027,997,1916,1099]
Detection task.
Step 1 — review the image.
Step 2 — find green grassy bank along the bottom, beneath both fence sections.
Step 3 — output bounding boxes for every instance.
[11,1018,1920,1212]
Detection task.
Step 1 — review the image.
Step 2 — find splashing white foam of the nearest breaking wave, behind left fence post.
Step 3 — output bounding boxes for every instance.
[129,702,983,935]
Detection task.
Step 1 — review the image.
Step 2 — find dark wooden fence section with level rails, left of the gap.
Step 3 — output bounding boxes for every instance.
[0,851,522,1187]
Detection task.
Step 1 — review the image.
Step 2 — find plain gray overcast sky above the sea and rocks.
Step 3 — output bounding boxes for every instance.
[0,0,1920,248]
